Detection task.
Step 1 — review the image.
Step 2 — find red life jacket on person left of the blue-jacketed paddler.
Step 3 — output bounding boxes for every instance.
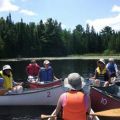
[26,63,40,76]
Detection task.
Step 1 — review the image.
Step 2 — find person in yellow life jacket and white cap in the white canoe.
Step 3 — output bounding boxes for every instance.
[0,65,23,93]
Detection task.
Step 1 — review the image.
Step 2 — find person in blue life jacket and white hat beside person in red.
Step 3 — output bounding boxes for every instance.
[38,60,58,82]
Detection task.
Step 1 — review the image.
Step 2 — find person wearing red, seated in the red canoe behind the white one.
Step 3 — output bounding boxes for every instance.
[26,59,40,77]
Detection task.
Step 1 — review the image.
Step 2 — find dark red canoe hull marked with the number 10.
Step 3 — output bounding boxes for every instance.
[90,87,120,120]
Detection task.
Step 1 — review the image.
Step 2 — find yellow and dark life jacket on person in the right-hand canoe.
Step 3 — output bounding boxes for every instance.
[96,67,108,81]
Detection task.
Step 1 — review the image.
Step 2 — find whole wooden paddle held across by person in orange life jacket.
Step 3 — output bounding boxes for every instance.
[41,108,120,119]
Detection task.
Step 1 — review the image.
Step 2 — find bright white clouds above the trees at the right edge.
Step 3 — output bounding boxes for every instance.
[86,6,120,32]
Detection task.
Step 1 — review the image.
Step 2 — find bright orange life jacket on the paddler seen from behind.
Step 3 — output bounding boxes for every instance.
[62,91,87,120]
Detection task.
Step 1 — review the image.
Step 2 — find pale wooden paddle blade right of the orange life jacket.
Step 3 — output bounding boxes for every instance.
[91,108,120,117]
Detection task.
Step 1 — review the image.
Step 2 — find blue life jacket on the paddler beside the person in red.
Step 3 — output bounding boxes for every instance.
[39,66,53,82]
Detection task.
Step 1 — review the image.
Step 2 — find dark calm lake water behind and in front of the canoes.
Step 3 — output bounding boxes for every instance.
[0,60,120,120]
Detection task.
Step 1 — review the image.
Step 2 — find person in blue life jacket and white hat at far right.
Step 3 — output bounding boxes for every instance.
[106,58,119,77]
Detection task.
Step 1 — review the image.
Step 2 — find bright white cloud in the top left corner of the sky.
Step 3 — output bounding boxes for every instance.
[0,0,19,12]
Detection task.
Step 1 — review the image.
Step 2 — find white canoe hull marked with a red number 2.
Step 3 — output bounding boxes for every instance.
[0,85,65,106]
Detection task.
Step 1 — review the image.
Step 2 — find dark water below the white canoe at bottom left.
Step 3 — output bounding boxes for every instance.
[0,106,55,120]
